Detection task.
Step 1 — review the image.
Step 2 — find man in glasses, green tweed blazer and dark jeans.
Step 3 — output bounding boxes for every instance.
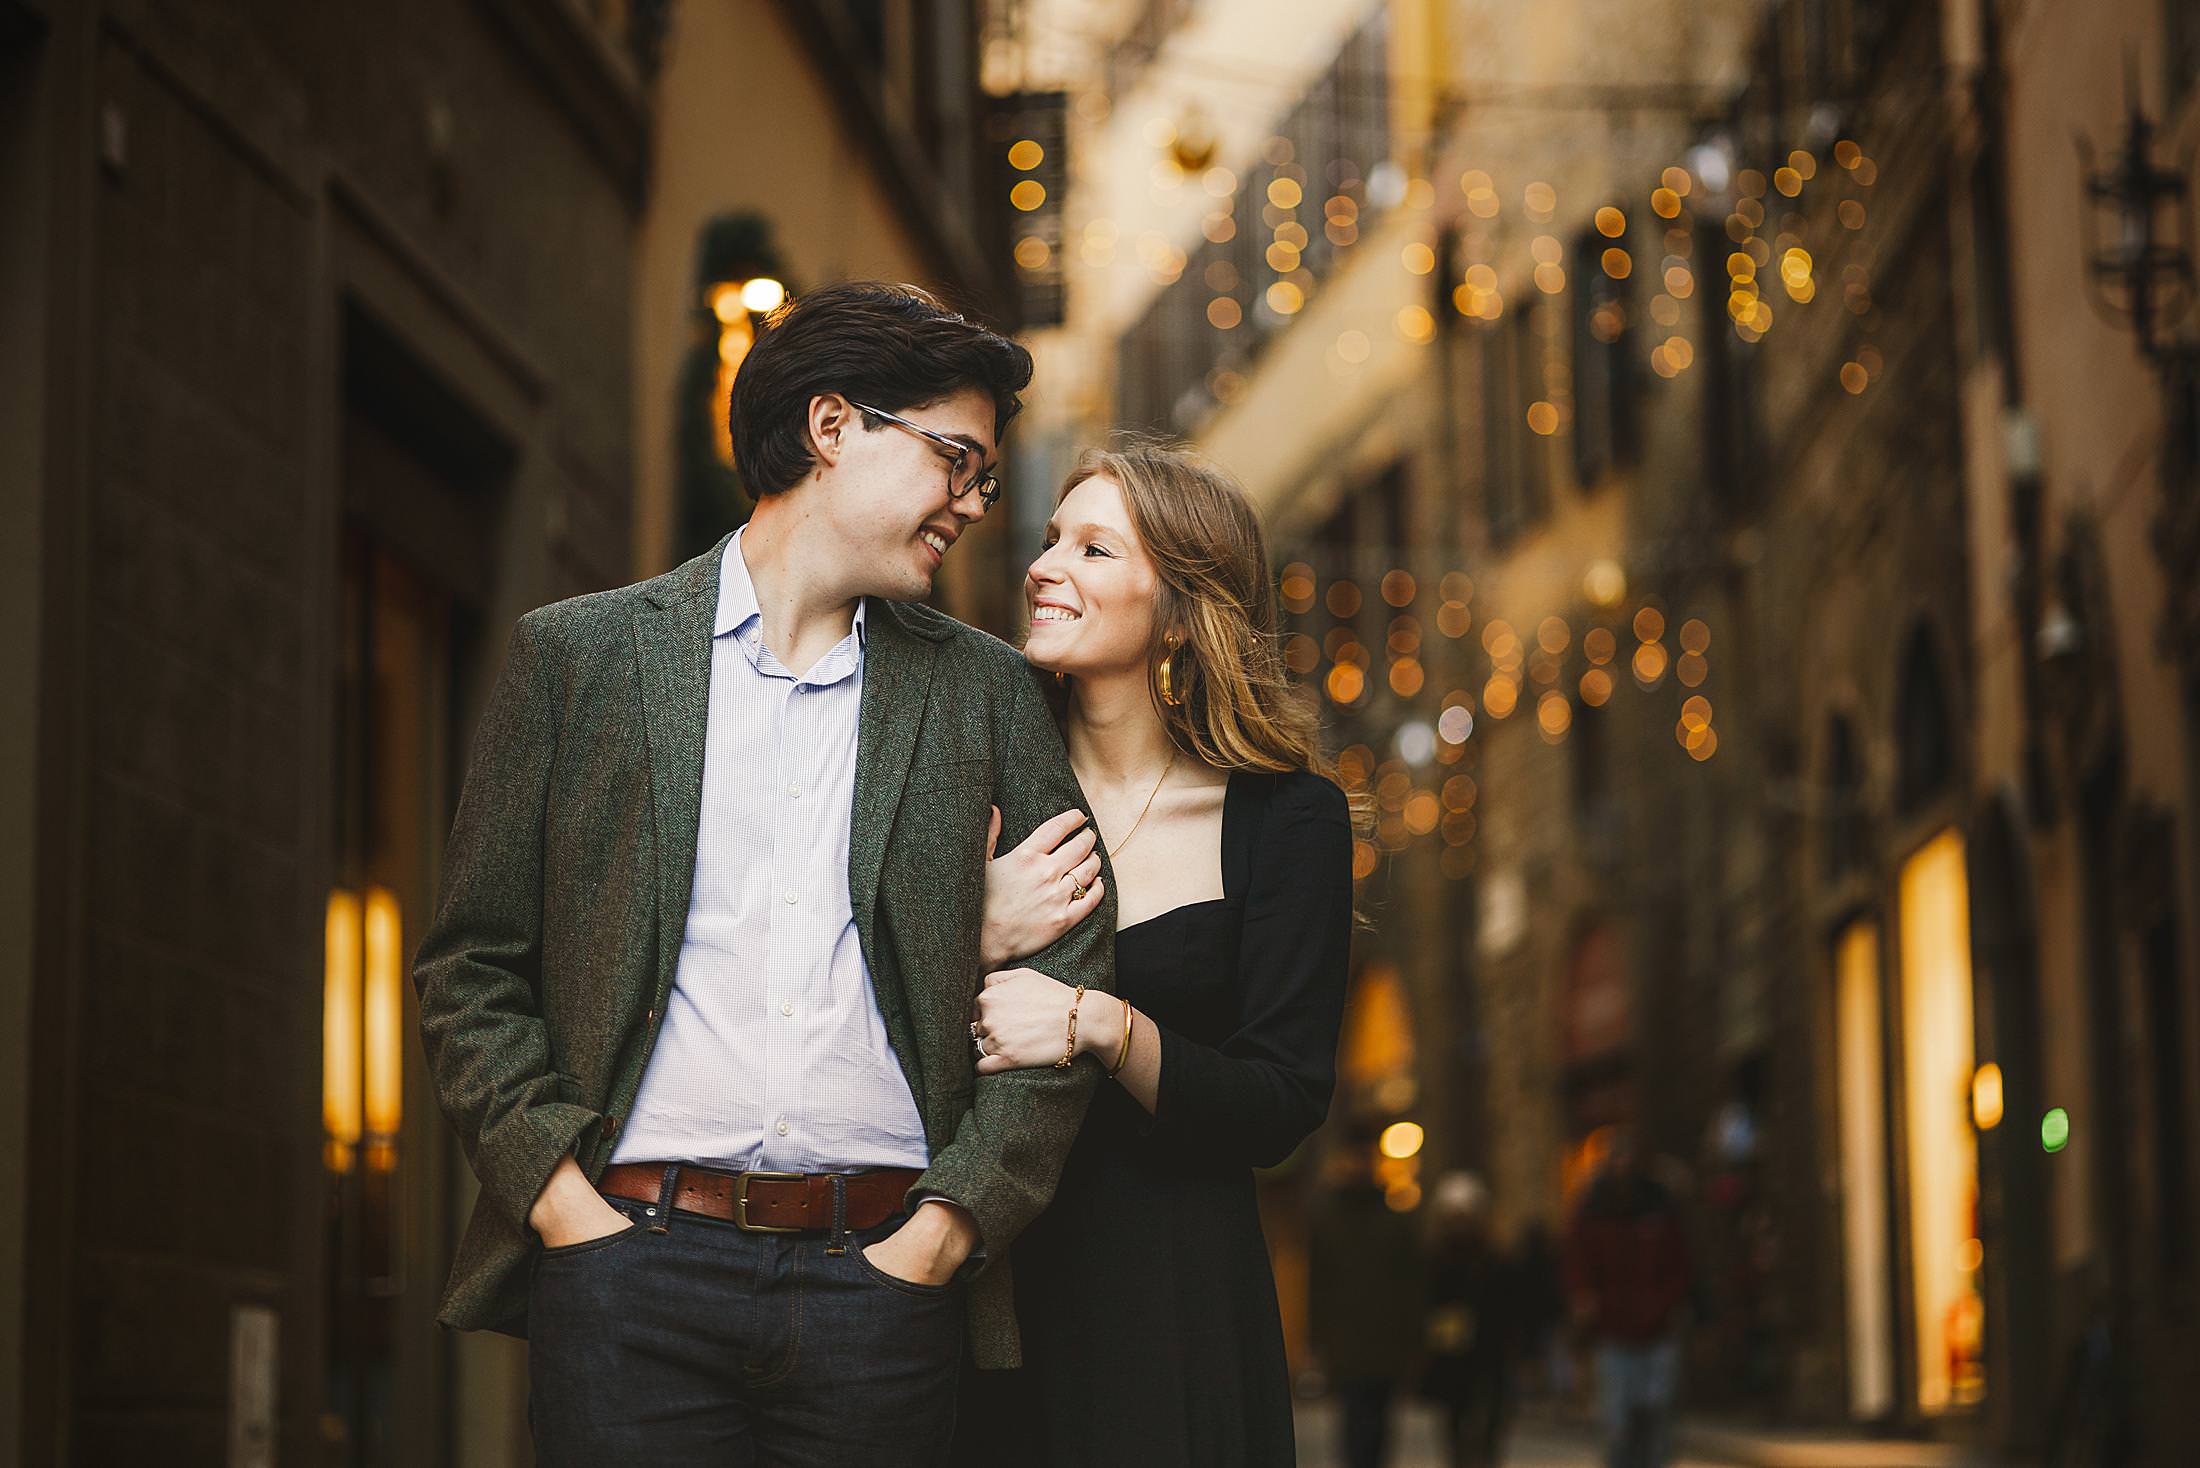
[414,284,1113,1468]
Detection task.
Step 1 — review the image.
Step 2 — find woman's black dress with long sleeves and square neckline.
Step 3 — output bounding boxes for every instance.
[950,773,1353,1468]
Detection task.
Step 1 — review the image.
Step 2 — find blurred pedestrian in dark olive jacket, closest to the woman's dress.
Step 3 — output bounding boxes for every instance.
[1307,1127,1428,1468]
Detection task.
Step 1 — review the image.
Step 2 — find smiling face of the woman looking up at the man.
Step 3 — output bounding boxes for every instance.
[1023,475,1159,678]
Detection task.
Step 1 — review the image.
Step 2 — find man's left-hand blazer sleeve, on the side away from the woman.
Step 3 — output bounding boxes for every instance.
[414,616,596,1228]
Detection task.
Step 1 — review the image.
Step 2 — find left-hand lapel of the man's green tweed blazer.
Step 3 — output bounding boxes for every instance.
[634,537,730,988]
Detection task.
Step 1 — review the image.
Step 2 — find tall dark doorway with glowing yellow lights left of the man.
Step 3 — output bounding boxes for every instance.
[321,308,510,1468]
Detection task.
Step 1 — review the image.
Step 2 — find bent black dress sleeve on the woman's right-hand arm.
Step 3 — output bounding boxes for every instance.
[1153,775,1353,1166]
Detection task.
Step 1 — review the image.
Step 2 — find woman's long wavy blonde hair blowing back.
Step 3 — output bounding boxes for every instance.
[1054,438,1338,781]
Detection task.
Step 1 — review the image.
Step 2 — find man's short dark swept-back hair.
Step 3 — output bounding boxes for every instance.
[730,280,1032,497]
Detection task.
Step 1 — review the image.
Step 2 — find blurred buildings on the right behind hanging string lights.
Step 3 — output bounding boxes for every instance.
[1038,0,2200,1461]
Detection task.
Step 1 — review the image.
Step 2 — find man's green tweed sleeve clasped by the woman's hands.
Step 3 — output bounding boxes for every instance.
[913,671,1115,1257]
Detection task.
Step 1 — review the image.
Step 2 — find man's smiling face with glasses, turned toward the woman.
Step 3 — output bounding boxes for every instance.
[803,387,999,601]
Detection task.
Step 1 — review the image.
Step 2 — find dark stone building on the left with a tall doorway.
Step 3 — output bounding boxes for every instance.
[0,0,1005,1466]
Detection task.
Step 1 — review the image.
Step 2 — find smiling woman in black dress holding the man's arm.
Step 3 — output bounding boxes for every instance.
[955,445,1353,1468]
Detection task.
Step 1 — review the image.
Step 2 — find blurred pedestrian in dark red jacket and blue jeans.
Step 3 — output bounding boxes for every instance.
[1566,1127,1692,1468]
